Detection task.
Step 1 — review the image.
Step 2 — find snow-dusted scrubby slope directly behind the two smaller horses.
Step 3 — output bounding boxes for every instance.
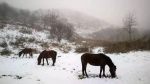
[0,24,74,55]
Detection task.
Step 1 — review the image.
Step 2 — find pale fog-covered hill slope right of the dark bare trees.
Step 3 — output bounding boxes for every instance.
[59,9,110,38]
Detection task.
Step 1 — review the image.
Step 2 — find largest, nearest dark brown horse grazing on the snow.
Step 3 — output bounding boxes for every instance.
[81,53,116,78]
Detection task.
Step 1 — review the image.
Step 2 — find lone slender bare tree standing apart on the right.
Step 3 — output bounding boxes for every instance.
[123,12,137,41]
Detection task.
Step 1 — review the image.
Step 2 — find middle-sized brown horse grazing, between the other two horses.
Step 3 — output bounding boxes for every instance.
[37,50,57,66]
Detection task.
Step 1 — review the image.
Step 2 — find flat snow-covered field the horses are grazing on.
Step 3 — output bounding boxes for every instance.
[0,51,150,84]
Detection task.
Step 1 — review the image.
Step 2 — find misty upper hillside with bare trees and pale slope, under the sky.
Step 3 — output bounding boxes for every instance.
[0,2,110,39]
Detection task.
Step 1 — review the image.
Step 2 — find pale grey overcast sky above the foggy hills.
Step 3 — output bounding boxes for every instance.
[0,0,150,28]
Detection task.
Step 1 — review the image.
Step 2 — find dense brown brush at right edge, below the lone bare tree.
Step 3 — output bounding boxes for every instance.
[103,38,150,53]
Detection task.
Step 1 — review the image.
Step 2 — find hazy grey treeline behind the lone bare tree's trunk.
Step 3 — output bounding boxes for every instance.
[91,27,150,41]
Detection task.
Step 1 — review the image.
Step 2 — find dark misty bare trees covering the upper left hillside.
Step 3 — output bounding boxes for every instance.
[0,2,74,41]
